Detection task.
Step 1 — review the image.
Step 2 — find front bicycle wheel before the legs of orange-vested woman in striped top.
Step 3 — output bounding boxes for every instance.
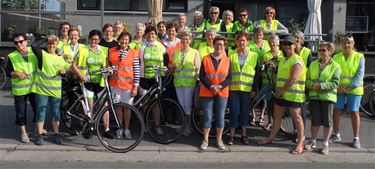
[95,103,145,153]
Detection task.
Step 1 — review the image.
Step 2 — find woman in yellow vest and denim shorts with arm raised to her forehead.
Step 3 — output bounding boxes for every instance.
[31,35,71,145]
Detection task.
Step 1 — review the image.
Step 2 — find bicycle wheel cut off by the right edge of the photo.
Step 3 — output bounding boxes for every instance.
[360,82,375,118]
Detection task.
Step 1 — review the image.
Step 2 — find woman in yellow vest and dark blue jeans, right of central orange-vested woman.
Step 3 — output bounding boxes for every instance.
[228,32,258,145]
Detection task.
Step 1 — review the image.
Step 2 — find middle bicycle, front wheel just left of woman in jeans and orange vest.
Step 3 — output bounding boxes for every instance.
[134,66,187,144]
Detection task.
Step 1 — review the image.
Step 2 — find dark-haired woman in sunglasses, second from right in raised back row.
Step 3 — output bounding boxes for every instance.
[232,8,254,33]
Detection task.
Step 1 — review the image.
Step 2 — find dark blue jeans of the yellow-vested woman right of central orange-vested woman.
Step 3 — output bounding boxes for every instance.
[229,91,251,128]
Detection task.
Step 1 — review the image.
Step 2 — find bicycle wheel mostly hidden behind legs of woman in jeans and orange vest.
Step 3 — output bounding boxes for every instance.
[191,107,230,137]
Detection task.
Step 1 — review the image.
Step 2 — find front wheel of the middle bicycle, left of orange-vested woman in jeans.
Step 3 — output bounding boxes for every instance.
[146,98,186,144]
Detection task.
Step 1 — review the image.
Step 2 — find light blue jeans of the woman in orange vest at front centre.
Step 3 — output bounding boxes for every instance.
[200,96,228,128]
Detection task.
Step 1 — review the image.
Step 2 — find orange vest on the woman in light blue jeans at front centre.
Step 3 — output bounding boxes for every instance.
[199,55,230,97]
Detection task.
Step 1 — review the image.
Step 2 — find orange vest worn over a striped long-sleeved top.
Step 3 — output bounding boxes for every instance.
[108,47,139,90]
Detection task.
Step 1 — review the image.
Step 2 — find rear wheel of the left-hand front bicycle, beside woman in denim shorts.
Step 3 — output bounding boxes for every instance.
[60,95,87,135]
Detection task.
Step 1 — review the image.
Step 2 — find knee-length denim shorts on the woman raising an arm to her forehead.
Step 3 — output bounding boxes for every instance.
[35,94,61,122]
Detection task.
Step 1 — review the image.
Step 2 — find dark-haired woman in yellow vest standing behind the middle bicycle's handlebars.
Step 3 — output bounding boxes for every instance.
[140,26,169,135]
